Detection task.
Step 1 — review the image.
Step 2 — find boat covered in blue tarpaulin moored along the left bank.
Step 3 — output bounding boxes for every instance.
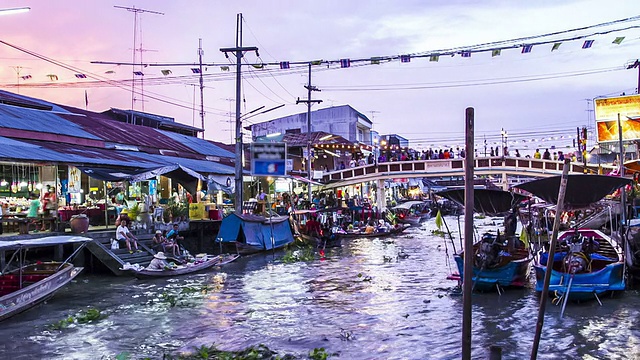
[216,213,294,255]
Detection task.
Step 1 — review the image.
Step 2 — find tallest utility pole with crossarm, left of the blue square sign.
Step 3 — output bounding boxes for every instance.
[220,14,258,214]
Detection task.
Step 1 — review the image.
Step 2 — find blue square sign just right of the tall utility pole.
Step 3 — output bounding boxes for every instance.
[251,143,287,176]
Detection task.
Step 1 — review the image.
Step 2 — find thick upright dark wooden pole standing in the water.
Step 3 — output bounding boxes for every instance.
[462,107,474,360]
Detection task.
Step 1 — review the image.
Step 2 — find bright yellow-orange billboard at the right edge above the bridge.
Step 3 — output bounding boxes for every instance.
[595,95,640,143]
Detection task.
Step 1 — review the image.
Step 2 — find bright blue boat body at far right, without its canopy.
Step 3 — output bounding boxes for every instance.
[533,229,626,301]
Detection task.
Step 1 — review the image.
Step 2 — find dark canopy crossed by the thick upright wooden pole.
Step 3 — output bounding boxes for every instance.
[436,189,528,215]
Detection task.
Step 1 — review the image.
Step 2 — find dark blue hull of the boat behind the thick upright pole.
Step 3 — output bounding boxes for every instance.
[454,255,530,292]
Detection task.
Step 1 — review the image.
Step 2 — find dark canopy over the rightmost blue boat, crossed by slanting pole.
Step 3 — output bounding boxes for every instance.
[514,175,631,209]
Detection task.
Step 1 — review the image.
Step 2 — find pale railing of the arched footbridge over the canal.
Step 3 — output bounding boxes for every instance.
[322,156,589,183]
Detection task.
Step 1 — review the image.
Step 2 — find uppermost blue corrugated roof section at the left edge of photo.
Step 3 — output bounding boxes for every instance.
[0,104,100,140]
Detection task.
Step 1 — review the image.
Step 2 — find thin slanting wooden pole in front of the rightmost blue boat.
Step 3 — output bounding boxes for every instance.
[531,158,571,360]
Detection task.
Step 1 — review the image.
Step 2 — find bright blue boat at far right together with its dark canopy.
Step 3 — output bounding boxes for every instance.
[516,175,631,307]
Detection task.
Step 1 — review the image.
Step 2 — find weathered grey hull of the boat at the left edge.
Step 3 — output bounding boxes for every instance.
[0,263,83,321]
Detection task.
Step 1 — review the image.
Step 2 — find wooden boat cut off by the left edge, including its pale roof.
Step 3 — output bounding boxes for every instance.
[0,236,92,321]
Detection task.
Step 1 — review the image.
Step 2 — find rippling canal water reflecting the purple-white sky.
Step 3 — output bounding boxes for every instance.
[0,217,640,359]
